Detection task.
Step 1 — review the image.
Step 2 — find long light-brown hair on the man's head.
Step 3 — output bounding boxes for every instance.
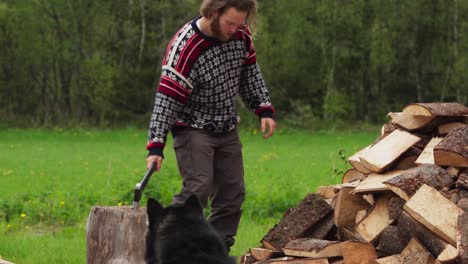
[200,0,257,31]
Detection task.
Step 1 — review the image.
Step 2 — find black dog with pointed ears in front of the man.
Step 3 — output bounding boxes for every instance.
[145,195,235,264]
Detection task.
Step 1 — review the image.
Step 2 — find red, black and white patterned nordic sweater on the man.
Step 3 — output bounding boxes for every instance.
[146,18,275,155]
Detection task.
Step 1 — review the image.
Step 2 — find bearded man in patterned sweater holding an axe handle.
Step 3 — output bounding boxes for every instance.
[146,0,276,250]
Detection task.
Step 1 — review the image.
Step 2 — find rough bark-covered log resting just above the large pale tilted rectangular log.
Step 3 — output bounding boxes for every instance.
[384,164,454,201]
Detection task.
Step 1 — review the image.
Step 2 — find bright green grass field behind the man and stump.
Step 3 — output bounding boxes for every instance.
[0,128,378,264]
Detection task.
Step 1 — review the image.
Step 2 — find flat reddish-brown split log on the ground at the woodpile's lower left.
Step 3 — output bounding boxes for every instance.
[283,238,343,258]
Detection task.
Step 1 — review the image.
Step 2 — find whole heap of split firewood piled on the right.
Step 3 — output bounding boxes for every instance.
[241,103,468,264]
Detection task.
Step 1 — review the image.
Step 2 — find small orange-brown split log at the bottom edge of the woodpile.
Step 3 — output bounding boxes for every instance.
[341,241,377,264]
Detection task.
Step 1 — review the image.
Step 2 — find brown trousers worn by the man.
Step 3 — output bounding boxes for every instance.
[173,128,245,238]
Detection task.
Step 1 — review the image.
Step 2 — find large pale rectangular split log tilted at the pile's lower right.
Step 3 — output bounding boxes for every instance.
[403,184,461,246]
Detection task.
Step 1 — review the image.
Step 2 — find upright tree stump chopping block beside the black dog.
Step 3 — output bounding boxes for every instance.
[86,206,147,264]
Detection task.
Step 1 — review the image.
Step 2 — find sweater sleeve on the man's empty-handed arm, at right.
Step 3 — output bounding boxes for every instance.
[240,29,275,117]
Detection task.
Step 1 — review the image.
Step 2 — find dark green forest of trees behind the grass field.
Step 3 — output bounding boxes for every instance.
[0,0,468,127]
